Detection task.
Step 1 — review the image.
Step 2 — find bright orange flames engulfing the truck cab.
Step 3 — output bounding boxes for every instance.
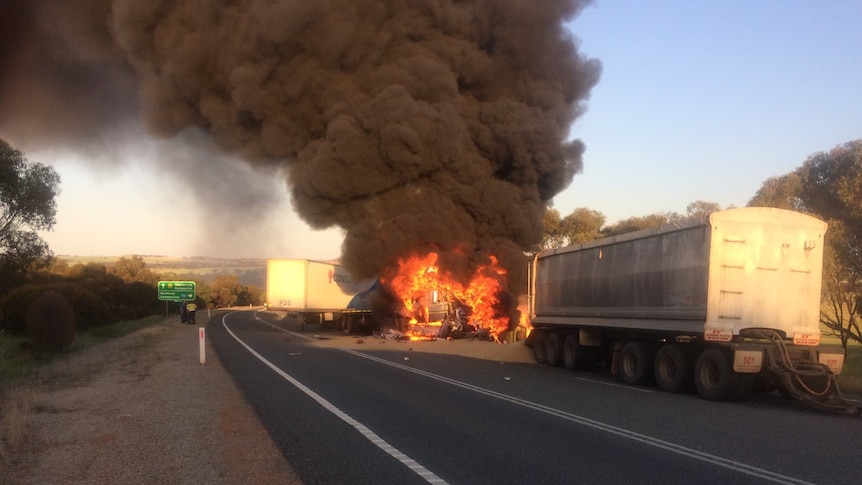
[384,252,509,340]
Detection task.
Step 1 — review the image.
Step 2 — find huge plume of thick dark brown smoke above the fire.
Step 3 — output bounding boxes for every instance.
[0,0,600,292]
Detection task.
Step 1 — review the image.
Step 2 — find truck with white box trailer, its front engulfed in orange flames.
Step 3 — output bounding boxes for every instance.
[266,252,517,340]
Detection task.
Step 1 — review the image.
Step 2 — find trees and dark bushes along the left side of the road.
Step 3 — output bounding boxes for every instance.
[0,140,264,462]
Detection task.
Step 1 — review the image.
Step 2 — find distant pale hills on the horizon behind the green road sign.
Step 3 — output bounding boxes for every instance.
[56,254,266,288]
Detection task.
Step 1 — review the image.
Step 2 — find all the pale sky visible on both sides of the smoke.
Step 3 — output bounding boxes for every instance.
[32,0,862,259]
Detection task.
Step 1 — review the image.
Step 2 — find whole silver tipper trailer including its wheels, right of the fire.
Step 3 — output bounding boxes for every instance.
[527,207,856,412]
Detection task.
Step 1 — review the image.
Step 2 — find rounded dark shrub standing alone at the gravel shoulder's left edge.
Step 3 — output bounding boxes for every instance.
[26,290,75,352]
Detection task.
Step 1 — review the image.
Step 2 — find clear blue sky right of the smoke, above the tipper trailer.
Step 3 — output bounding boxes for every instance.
[555,0,862,223]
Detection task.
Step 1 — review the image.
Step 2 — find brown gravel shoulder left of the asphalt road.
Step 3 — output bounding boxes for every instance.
[0,317,301,484]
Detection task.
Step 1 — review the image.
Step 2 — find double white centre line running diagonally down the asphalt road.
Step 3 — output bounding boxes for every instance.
[338,348,811,485]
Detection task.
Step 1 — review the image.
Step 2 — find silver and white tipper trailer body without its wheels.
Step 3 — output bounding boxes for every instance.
[531,208,826,345]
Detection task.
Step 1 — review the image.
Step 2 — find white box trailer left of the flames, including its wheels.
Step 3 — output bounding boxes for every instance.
[266,259,375,327]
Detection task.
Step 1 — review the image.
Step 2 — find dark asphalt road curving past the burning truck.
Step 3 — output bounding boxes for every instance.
[208,311,862,484]
